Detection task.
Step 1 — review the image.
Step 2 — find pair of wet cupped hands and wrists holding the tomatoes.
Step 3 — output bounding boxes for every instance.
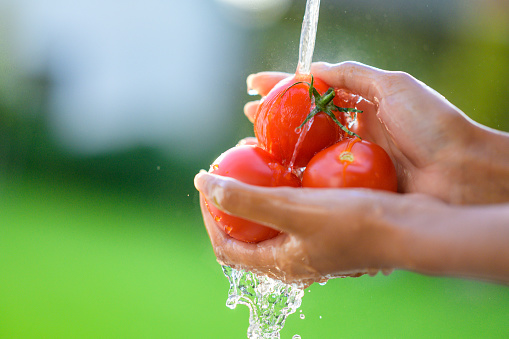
[195,62,509,285]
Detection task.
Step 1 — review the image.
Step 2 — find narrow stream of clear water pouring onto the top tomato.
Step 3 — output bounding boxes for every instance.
[297,0,320,74]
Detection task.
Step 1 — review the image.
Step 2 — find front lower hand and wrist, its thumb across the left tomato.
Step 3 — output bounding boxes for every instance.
[195,172,509,286]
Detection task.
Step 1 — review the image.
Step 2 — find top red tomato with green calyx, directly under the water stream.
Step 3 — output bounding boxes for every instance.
[254,75,356,167]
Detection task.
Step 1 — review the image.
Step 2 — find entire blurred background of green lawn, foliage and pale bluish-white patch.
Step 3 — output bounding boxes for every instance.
[0,0,509,338]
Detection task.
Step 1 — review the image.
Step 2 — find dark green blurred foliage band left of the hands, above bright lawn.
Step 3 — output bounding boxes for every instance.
[0,76,200,208]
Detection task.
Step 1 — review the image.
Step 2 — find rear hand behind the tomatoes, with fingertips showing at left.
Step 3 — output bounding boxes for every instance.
[244,62,509,204]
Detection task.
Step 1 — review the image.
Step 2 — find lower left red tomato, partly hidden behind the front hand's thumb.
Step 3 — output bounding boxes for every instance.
[207,145,300,243]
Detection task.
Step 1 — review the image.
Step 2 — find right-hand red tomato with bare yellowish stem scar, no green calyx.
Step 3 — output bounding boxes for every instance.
[302,138,398,192]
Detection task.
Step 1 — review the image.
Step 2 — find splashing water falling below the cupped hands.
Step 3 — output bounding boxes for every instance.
[222,266,304,339]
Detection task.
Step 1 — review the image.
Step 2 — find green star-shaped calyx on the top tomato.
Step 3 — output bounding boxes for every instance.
[281,75,362,139]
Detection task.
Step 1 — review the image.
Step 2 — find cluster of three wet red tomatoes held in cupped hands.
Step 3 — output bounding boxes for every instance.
[207,75,397,243]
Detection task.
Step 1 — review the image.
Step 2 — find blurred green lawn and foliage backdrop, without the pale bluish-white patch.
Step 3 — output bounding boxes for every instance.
[0,1,509,338]
